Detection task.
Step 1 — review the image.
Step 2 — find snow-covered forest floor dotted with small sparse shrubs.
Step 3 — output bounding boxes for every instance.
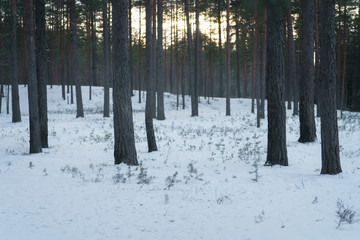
[0,87,360,240]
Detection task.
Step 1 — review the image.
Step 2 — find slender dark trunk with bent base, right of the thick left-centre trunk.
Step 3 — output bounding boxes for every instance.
[145,0,157,152]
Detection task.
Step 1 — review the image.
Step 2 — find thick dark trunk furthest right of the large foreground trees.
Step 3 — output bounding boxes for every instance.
[319,0,342,174]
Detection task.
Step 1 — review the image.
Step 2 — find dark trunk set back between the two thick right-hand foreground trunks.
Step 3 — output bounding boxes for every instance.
[299,0,316,143]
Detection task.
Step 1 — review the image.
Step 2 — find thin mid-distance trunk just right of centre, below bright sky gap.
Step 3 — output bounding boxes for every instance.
[191,0,200,117]
